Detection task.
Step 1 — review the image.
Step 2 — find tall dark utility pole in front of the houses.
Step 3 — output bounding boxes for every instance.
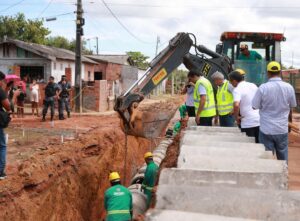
[75,0,84,113]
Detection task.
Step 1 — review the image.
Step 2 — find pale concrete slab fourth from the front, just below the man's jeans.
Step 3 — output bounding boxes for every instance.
[177,156,287,173]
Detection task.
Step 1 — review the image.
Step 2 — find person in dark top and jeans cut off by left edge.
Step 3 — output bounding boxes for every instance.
[0,71,10,180]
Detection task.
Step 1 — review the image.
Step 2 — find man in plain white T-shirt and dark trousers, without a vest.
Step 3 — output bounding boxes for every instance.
[229,70,259,143]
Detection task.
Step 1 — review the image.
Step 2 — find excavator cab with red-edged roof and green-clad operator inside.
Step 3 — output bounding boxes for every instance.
[216,32,286,86]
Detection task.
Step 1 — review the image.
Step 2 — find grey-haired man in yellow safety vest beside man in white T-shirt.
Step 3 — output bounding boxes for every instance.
[211,71,234,127]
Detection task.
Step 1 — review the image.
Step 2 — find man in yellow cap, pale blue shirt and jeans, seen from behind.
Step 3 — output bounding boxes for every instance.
[252,61,297,161]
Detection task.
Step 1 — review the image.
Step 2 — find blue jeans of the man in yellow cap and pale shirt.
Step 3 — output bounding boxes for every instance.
[259,131,288,161]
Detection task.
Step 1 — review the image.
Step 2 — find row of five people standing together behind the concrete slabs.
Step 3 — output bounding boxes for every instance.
[183,61,297,161]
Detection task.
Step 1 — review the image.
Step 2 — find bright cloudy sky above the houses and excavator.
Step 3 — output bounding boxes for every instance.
[0,0,300,68]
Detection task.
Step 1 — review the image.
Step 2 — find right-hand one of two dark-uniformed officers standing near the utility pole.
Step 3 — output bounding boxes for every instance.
[58,75,71,120]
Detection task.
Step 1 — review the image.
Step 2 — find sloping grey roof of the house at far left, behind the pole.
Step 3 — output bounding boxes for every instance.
[0,39,97,64]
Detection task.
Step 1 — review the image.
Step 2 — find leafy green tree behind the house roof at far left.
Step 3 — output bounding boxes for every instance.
[0,13,50,44]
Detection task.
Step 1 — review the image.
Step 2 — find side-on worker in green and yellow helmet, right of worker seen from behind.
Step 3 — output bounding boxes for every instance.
[142,152,158,208]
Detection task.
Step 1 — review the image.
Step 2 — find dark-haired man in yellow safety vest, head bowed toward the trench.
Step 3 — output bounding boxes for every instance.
[188,70,217,126]
